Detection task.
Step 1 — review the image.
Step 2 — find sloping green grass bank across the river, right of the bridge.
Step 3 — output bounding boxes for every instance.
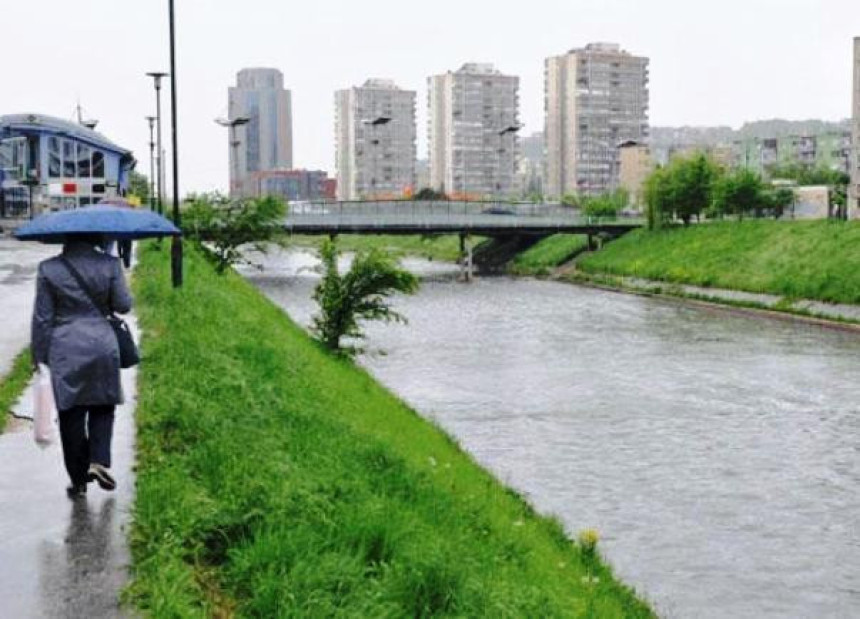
[578,221,860,303]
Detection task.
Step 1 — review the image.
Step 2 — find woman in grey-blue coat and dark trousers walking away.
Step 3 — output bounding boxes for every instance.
[31,236,132,498]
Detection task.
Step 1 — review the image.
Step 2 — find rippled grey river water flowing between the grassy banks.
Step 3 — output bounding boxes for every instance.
[247,251,860,618]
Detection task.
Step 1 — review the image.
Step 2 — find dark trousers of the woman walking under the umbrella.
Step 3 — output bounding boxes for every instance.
[59,406,116,485]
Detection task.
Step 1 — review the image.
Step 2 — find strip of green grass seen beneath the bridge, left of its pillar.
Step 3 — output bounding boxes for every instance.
[290,234,470,262]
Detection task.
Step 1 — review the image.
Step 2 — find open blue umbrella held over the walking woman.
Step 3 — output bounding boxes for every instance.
[14,204,182,243]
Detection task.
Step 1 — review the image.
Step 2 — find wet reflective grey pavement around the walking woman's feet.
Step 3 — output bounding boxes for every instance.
[0,322,136,619]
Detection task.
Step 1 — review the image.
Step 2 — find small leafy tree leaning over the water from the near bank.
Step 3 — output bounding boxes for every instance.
[313,241,418,356]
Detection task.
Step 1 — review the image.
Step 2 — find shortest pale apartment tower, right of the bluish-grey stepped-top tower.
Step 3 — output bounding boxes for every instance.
[335,79,417,200]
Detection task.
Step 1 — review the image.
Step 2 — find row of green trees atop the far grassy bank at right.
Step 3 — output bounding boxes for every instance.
[644,154,848,228]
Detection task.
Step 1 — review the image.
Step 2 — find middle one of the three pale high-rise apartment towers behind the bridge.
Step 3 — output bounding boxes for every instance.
[428,63,520,199]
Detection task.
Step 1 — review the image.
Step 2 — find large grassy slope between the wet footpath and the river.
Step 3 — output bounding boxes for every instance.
[127,247,651,617]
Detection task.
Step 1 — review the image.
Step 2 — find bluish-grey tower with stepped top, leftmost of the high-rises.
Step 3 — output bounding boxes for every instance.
[227,68,293,196]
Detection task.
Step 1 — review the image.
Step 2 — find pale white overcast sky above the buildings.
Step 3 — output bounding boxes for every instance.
[0,0,860,193]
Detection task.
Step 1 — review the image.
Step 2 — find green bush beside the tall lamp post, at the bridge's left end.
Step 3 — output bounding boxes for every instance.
[182,194,287,273]
